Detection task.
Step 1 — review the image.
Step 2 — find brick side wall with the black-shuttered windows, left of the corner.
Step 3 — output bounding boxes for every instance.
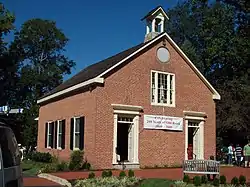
[37,91,96,166]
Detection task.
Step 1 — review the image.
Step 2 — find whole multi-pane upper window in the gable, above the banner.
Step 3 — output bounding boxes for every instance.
[151,71,175,106]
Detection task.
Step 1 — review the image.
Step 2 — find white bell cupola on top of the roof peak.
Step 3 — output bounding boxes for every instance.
[142,6,169,42]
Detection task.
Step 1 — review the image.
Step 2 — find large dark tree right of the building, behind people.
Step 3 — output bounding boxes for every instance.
[167,0,250,144]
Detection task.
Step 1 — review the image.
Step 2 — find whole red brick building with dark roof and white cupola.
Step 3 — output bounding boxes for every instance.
[37,7,220,169]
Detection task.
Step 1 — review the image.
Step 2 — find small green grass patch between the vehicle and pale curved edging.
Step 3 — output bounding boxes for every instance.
[21,160,45,176]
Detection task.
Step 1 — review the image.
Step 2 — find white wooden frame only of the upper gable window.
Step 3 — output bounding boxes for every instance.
[150,70,176,107]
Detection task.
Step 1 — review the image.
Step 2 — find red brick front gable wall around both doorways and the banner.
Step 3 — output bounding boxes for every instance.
[93,39,215,168]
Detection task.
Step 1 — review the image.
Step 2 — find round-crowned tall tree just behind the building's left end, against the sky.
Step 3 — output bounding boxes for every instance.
[10,19,75,146]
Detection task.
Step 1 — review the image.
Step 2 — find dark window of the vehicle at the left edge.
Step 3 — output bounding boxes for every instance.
[0,127,20,168]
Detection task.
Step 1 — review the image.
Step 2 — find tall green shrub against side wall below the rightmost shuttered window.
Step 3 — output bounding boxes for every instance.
[69,151,83,170]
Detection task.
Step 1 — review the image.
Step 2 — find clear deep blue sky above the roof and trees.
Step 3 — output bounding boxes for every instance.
[2,0,180,80]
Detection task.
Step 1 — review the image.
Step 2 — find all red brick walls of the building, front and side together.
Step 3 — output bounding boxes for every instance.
[38,36,216,168]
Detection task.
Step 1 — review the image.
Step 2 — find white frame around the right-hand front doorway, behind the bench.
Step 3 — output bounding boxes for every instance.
[184,111,206,160]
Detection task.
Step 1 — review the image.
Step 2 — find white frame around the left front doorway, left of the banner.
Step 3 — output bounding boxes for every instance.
[112,104,142,165]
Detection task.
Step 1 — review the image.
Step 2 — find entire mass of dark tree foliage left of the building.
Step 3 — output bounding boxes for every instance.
[0,4,75,147]
